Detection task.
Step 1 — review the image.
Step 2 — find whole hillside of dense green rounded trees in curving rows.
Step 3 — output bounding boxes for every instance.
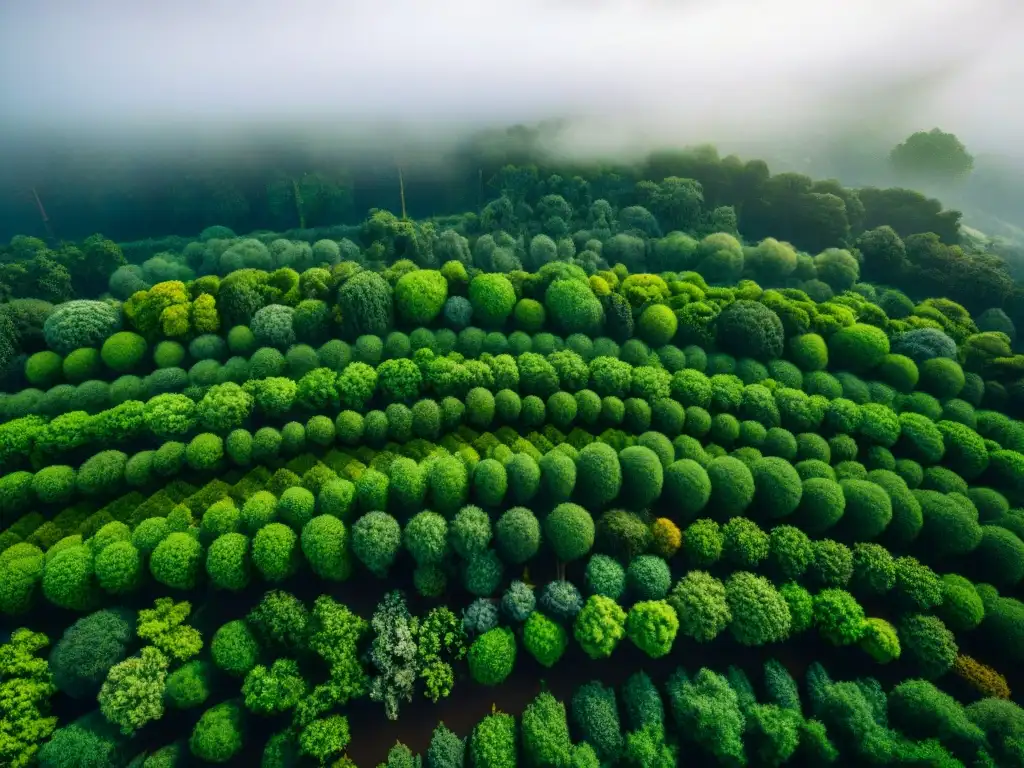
[0,139,1024,768]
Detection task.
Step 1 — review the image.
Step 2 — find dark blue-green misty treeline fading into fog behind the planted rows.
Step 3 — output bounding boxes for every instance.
[0,124,959,251]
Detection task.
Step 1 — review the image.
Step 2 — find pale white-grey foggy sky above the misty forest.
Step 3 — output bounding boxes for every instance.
[0,0,1024,165]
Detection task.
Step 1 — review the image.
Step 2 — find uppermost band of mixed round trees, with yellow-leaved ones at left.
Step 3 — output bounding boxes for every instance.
[0,221,1016,409]
